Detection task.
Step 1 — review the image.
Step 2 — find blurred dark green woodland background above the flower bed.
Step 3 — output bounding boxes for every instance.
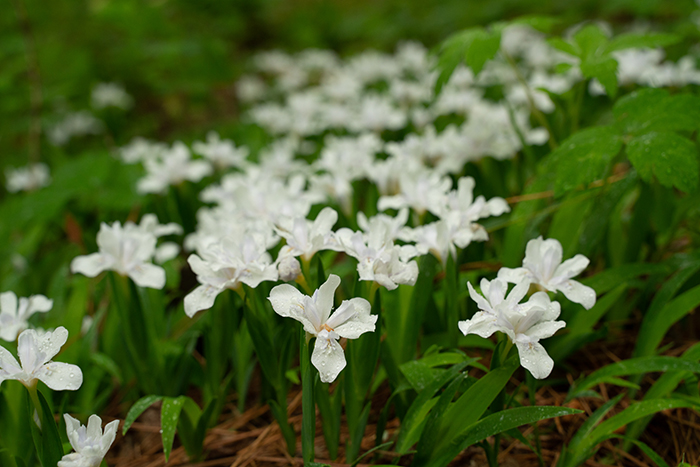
[0,0,697,166]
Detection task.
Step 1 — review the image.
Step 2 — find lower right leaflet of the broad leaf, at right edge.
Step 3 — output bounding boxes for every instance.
[627,132,700,193]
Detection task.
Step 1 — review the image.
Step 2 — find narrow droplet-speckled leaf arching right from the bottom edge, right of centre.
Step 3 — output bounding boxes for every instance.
[430,406,581,467]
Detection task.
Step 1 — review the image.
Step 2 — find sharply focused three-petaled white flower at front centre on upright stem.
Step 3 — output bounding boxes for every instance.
[269,274,377,383]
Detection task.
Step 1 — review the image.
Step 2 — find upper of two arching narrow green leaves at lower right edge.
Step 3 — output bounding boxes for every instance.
[566,357,700,401]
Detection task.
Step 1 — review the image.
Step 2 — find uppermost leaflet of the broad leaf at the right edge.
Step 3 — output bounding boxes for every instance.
[613,88,700,135]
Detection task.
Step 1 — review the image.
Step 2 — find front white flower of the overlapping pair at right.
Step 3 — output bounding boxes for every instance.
[459,279,566,379]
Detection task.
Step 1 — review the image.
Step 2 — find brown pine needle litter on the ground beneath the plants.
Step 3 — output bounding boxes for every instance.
[106,331,700,467]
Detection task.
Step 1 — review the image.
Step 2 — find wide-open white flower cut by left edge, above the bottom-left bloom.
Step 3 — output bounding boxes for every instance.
[0,326,83,391]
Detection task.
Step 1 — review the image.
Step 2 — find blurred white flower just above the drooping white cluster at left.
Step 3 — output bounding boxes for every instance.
[136,141,212,194]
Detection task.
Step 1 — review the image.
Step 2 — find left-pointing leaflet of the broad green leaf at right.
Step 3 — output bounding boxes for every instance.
[540,126,622,196]
